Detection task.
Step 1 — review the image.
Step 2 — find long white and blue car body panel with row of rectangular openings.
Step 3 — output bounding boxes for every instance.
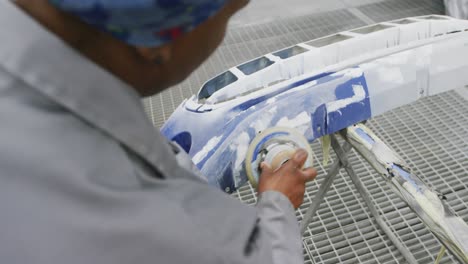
[161,16,468,192]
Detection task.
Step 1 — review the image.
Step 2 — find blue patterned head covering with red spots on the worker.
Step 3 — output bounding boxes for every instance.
[49,0,227,47]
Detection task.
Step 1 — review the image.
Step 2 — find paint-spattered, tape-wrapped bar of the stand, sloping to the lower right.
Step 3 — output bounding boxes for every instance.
[342,125,468,263]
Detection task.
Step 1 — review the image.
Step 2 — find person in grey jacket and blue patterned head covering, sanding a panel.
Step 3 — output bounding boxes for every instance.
[0,0,317,264]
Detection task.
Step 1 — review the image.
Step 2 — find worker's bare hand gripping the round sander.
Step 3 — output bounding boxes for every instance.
[258,149,317,209]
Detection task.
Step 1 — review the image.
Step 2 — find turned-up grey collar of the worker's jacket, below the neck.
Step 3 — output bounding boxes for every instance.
[0,1,183,178]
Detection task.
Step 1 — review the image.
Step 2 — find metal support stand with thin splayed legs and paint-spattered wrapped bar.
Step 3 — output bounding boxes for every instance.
[301,125,468,263]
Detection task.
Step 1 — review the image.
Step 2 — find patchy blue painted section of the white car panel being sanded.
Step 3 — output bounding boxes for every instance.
[162,69,371,192]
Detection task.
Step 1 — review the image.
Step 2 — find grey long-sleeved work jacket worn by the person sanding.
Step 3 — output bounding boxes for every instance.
[0,1,303,264]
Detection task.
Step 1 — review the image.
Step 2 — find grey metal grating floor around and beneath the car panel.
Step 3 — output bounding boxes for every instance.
[144,0,468,263]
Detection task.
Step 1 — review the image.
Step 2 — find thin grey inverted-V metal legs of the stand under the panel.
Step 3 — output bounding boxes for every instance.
[301,135,418,264]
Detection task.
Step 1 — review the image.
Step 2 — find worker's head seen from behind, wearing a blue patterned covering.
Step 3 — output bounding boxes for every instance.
[16,0,248,95]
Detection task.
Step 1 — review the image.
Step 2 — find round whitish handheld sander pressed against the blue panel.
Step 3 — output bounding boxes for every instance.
[245,127,313,187]
